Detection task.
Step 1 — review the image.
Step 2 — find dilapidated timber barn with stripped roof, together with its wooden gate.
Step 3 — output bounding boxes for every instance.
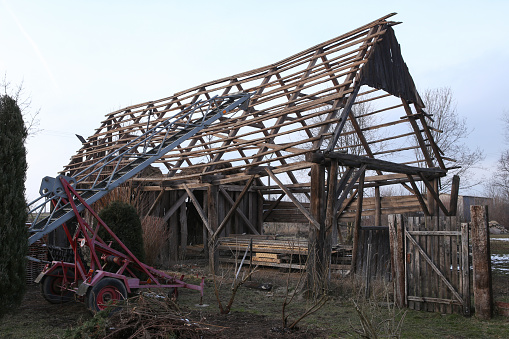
[32,14,492,312]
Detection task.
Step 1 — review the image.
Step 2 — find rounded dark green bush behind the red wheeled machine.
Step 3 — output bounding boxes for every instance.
[99,201,145,262]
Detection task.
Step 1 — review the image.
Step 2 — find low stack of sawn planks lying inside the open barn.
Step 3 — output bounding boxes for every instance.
[217,235,352,270]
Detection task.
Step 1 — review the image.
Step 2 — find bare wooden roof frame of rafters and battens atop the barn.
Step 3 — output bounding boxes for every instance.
[59,14,452,224]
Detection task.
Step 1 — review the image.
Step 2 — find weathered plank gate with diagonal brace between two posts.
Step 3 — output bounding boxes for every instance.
[401,217,470,315]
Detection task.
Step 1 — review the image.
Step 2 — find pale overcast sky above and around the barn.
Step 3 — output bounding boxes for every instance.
[0,0,509,199]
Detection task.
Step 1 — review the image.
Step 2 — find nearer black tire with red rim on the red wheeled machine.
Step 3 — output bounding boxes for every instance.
[86,278,127,314]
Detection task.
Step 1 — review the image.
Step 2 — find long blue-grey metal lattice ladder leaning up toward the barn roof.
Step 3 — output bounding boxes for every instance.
[27,93,251,245]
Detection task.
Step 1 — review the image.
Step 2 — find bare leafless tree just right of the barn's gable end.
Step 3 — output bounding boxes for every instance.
[423,87,484,192]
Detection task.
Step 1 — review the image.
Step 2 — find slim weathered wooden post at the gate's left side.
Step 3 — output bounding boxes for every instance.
[389,214,406,307]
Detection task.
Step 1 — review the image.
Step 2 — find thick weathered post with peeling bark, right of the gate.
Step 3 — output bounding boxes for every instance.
[470,206,493,320]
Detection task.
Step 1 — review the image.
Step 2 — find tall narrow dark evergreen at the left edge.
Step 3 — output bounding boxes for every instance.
[0,95,28,317]
